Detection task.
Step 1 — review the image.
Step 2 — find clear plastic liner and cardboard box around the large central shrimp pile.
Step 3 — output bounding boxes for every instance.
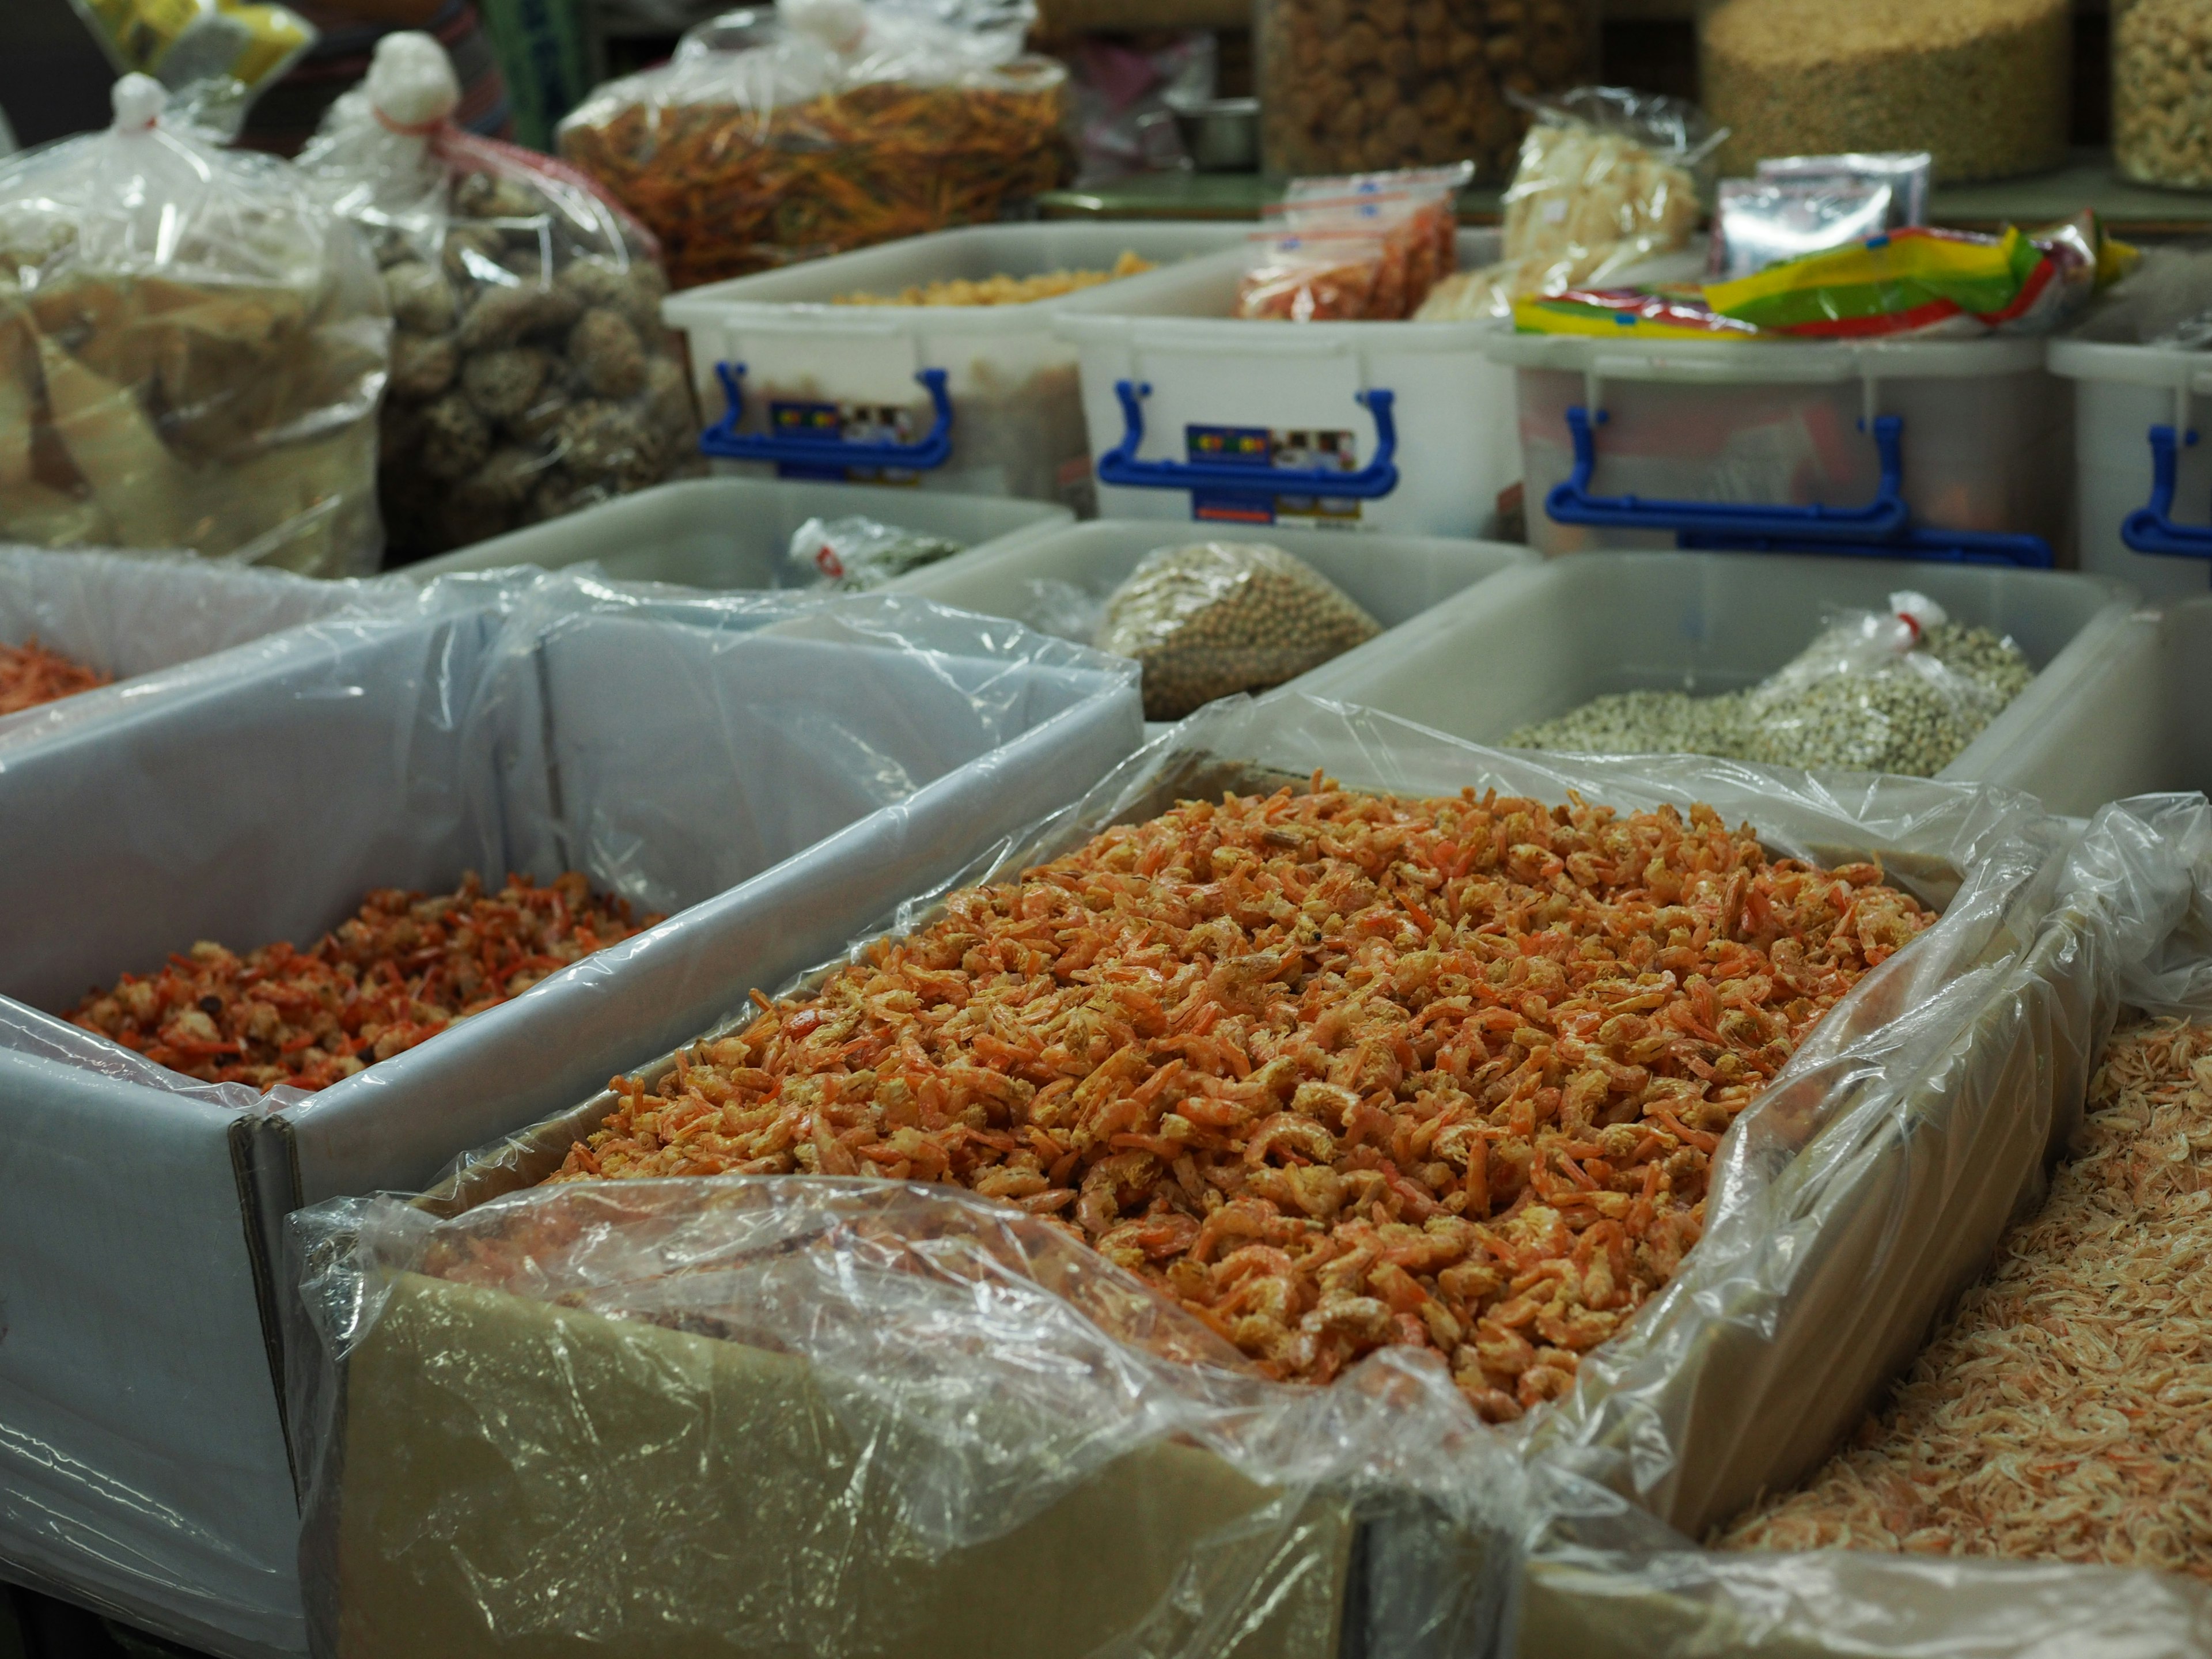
[276,692,2158,1654]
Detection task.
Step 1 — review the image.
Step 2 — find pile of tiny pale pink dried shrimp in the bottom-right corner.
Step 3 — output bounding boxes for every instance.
[1719,1020,2212,1580]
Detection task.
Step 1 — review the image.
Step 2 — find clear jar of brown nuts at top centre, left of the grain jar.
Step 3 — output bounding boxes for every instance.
[1252,0,1597,177]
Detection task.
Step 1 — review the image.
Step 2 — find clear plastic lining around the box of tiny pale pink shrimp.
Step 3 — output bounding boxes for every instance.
[1517,796,2212,1659]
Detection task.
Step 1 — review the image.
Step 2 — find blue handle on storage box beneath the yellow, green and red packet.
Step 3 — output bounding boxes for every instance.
[1544,405,2057,571]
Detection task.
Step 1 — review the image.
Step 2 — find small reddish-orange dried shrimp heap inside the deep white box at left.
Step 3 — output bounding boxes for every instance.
[69,872,659,1088]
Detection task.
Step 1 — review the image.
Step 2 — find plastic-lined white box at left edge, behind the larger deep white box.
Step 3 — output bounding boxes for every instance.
[0,546,421,748]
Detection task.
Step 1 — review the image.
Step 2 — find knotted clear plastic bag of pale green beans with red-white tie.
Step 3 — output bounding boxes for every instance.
[1741,590,2035,779]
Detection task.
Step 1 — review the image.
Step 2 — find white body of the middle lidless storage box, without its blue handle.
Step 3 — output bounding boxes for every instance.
[1055,230,1520,537]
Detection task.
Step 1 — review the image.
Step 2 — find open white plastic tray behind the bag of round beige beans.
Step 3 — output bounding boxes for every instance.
[889,518,1535,646]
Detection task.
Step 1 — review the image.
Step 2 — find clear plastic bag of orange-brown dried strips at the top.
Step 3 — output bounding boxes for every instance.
[560,0,1075,287]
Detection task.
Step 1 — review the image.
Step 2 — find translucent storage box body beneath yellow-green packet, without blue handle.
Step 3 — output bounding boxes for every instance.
[1488,332,2073,566]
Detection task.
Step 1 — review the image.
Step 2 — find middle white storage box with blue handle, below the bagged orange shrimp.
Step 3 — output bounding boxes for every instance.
[1055,230,1520,535]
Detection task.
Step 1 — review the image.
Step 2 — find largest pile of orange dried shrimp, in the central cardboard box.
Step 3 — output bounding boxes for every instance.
[553,777,1931,1420]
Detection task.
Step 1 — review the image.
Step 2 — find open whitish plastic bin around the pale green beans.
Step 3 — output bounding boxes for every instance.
[1298,553,2161,812]
